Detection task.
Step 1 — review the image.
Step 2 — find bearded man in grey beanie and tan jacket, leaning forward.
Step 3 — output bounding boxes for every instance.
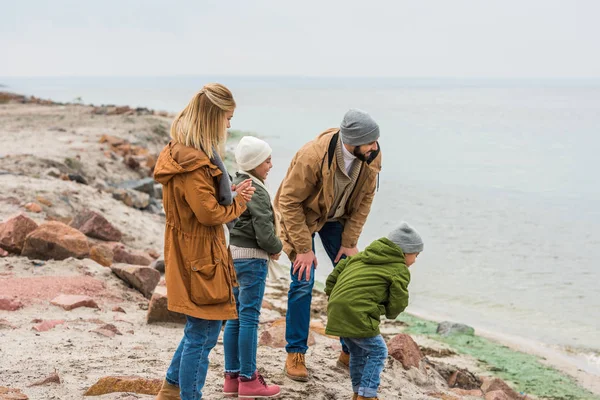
[275,109,381,382]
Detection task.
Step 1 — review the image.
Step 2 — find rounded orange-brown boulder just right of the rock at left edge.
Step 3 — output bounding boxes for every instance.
[21,221,90,260]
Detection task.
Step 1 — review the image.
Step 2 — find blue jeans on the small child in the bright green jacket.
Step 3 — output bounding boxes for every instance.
[344,335,387,397]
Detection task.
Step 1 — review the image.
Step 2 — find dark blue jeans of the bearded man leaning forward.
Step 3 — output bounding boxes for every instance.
[285,221,348,354]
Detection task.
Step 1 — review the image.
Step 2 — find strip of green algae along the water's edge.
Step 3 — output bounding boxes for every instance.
[398,314,600,400]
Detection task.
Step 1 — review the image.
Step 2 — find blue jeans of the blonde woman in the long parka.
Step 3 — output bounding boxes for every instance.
[166,315,223,400]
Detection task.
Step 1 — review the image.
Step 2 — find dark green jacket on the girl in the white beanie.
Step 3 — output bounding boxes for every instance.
[231,172,283,254]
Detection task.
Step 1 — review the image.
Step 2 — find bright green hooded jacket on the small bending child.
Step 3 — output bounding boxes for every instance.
[325,238,410,338]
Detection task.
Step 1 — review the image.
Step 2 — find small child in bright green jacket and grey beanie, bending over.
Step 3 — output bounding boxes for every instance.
[325,222,423,400]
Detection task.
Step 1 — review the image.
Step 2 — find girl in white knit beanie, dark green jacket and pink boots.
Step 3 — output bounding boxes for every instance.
[223,136,283,398]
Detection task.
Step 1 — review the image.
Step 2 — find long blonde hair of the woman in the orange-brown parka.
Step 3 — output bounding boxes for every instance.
[171,83,235,158]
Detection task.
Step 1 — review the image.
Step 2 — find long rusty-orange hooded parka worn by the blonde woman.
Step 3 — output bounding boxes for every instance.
[154,143,246,320]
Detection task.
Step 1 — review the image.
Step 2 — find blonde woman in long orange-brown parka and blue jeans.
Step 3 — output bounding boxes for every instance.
[154,83,254,400]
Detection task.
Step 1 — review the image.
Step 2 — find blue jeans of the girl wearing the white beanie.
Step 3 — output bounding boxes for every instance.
[223,258,267,378]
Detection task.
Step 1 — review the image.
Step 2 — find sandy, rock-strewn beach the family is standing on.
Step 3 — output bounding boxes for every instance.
[0,94,600,400]
